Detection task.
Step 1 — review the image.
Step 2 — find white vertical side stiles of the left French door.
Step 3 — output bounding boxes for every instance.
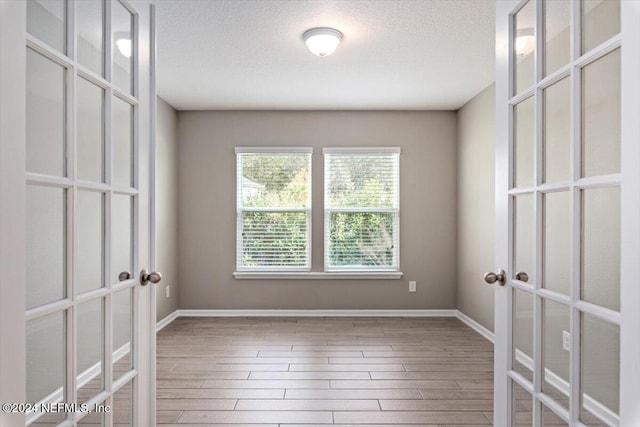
[0,0,156,426]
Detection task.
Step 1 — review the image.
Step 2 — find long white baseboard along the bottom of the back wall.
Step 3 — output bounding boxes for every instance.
[178,310,457,317]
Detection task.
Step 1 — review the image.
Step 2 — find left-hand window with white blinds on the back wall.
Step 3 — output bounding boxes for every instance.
[236,148,312,271]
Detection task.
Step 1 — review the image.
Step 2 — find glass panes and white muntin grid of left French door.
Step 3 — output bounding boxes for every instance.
[26,0,139,425]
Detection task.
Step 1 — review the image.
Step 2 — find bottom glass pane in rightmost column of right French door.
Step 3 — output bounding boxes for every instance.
[580,313,620,426]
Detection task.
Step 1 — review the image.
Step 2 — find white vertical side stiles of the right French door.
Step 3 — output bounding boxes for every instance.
[494,0,640,426]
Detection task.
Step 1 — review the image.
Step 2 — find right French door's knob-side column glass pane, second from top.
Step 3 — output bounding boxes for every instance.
[513,97,535,187]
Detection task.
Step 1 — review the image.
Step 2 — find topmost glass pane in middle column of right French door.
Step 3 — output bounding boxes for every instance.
[543,0,571,76]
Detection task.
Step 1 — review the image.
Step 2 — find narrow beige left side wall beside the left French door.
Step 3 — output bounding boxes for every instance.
[156,98,178,320]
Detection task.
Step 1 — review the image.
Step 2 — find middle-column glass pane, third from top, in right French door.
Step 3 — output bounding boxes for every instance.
[532,191,571,295]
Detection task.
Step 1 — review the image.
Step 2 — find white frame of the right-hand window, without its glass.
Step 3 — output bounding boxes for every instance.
[322,147,402,273]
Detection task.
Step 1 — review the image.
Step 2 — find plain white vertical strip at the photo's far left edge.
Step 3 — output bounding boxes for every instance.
[0,0,26,426]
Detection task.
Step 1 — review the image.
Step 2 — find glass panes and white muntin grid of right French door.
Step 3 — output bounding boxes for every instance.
[507,0,621,426]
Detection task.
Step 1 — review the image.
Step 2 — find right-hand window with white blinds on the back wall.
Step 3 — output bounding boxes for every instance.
[323,148,400,271]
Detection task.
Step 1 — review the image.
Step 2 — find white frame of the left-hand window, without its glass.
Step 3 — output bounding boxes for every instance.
[235,147,313,273]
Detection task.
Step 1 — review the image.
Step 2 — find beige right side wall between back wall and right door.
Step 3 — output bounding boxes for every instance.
[457,85,495,331]
